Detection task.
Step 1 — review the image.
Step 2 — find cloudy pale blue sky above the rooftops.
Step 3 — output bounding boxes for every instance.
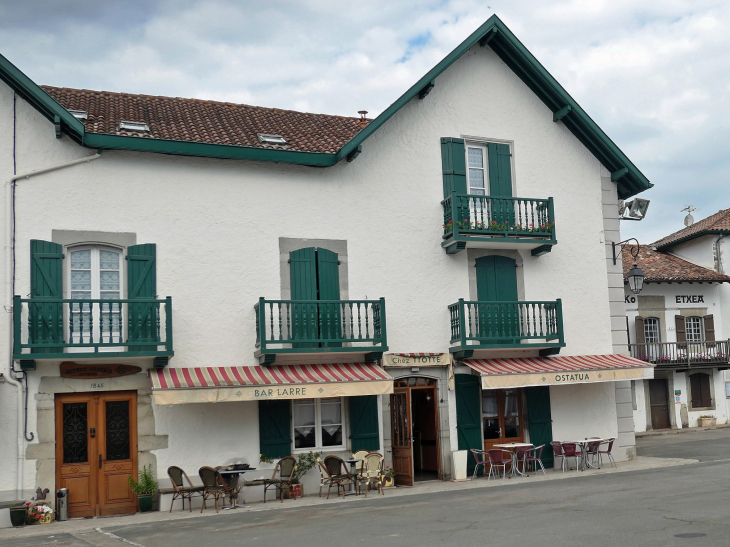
[0,0,730,243]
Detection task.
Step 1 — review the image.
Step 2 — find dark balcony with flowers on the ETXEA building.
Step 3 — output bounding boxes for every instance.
[629,340,730,369]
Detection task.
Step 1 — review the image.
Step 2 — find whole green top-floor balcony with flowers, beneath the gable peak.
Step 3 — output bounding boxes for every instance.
[441,193,558,256]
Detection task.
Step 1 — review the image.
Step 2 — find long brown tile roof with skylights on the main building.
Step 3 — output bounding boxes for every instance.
[41,85,369,154]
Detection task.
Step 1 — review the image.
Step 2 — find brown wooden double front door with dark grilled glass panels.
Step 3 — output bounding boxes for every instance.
[56,392,137,518]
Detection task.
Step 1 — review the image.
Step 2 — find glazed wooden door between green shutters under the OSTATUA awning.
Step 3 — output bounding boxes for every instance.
[482,389,524,450]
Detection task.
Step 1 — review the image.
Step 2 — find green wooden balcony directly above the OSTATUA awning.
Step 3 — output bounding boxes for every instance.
[449,299,565,359]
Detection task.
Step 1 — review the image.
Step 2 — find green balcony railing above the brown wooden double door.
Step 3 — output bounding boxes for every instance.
[13,296,173,359]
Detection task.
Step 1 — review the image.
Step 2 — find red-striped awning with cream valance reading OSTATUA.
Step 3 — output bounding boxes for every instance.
[462,354,654,389]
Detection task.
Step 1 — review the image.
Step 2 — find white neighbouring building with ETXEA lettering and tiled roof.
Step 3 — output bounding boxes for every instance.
[623,227,730,432]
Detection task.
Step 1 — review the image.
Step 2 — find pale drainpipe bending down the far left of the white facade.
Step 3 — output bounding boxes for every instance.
[4,143,101,499]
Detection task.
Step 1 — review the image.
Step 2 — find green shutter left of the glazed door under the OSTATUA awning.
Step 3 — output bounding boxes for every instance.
[454,374,484,476]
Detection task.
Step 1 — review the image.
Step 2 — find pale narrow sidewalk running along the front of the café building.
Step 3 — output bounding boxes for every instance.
[0,457,698,543]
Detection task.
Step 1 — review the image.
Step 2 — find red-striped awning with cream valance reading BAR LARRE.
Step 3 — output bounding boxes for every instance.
[144,363,393,405]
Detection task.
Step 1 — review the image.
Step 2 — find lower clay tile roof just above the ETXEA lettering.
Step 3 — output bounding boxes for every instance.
[621,245,730,283]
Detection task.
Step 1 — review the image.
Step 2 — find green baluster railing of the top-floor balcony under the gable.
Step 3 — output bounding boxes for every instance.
[441,192,556,250]
